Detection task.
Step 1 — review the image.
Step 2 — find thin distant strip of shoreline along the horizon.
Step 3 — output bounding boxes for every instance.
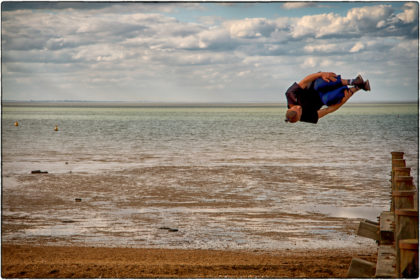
[2,100,418,108]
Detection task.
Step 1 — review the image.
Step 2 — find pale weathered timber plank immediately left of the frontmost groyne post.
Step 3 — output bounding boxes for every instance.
[375,245,397,278]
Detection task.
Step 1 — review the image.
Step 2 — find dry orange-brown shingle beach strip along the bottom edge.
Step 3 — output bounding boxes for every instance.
[2,245,376,278]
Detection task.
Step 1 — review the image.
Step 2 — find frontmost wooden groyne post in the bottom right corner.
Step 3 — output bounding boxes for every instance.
[399,239,419,278]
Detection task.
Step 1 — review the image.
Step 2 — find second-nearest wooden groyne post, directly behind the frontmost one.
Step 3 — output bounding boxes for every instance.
[395,209,419,275]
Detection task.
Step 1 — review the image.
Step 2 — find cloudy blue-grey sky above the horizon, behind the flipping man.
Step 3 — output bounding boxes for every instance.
[1,1,419,103]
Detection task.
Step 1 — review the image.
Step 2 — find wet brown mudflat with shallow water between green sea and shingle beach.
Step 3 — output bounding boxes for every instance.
[2,166,381,250]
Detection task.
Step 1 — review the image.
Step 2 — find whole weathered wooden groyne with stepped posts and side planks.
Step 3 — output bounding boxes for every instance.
[347,152,419,278]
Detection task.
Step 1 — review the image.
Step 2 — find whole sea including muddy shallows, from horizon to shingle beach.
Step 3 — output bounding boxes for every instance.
[1,102,419,250]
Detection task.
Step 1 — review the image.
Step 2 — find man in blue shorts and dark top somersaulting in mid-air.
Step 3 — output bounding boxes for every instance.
[285,72,370,123]
